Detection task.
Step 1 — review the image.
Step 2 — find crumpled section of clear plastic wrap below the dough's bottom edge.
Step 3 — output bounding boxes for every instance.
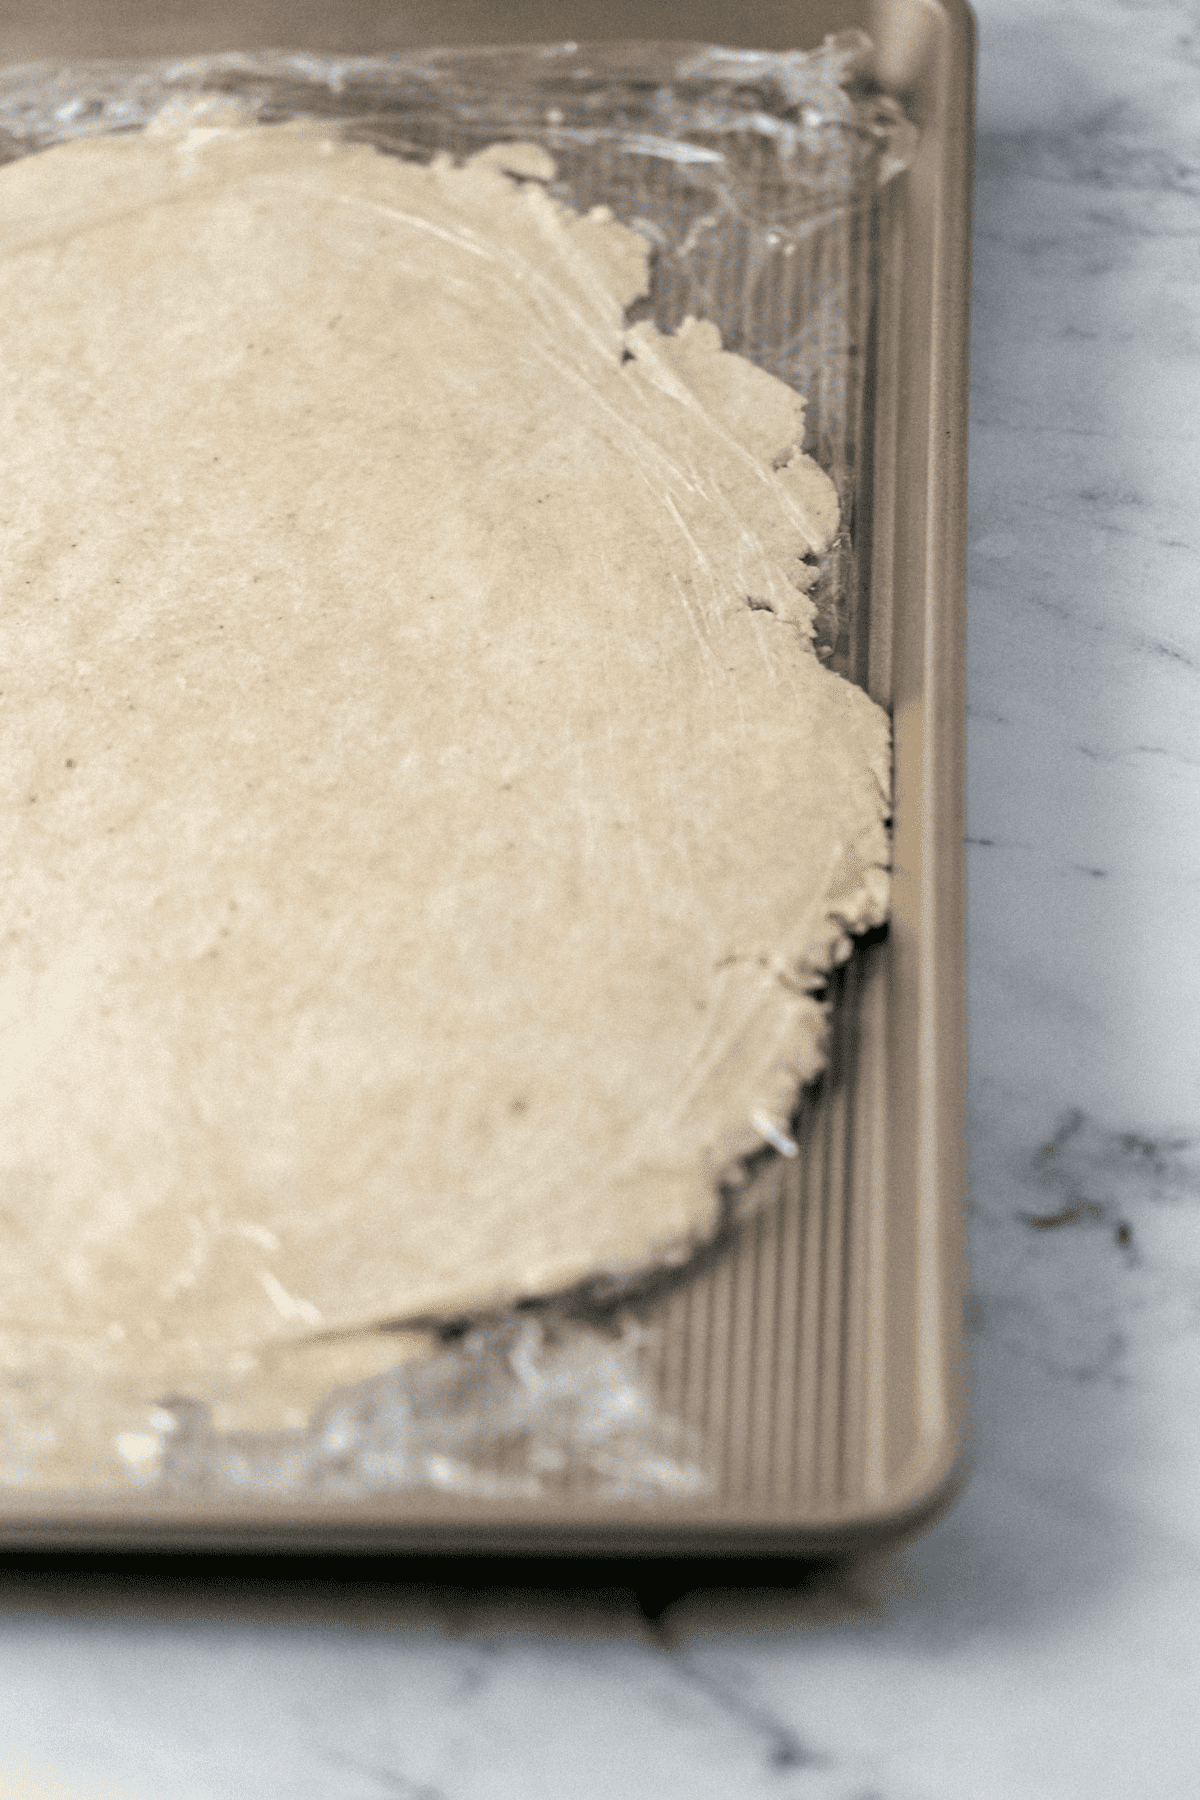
[144,1318,707,1501]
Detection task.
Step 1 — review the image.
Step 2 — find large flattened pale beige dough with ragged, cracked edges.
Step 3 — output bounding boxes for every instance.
[0,126,889,1468]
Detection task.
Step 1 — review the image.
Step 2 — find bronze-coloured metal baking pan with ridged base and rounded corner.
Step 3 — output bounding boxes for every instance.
[0,0,973,1555]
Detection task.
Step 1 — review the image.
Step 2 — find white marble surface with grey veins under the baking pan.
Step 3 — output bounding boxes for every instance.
[0,0,1200,1800]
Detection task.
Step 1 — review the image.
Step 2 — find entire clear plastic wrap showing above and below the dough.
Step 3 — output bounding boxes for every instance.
[0,31,916,1501]
